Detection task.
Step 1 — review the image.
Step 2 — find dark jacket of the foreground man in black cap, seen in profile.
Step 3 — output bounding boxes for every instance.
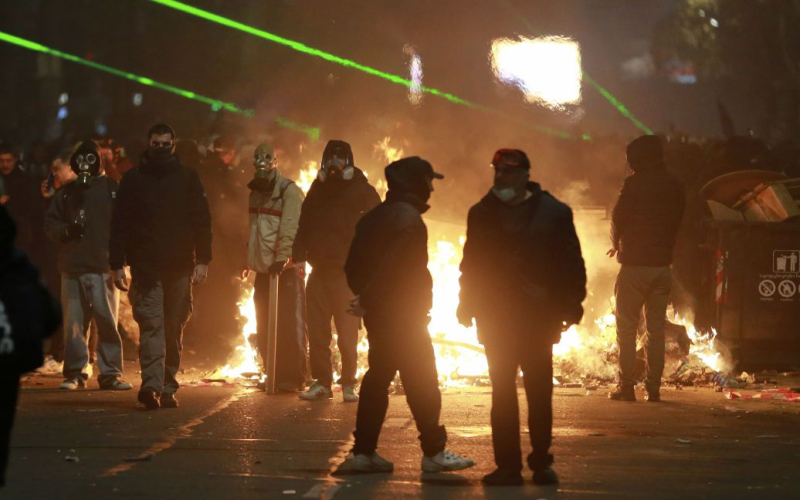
[345,160,433,321]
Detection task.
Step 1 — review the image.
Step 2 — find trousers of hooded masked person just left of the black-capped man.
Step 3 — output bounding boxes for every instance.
[307,269,360,387]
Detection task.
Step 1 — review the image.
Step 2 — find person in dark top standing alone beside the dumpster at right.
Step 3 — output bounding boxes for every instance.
[608,135,686,403]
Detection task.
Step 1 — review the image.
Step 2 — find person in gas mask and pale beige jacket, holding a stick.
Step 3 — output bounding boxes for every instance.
[242,144,307,392]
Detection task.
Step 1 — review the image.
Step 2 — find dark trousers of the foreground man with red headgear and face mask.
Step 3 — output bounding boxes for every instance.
[484,332,553,471]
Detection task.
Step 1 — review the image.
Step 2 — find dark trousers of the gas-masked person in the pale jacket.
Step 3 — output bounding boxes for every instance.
[253,269,308,388]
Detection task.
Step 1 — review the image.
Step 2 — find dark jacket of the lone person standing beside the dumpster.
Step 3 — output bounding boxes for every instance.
[611,166,686,267]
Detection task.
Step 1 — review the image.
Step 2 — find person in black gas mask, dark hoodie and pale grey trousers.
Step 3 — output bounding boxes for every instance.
[45,141,132,391]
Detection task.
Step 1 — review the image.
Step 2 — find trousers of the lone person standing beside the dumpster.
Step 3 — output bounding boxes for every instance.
[614,265,672,391]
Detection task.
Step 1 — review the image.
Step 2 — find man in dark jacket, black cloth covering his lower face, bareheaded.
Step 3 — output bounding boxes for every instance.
[109,123,216,409]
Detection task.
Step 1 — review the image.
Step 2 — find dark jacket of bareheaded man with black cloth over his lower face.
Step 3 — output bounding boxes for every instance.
[109,153,216,278]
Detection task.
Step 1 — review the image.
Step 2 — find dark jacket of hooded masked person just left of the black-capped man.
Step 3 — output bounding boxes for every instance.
[292,168,381,272]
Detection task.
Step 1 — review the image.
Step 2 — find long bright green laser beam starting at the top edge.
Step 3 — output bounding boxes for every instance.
[150,0,479,108]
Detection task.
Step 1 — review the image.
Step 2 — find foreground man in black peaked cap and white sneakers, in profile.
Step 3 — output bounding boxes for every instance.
[336,156,475,474]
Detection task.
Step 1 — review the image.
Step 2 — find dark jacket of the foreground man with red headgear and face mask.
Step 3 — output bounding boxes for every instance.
[460,183,586,342]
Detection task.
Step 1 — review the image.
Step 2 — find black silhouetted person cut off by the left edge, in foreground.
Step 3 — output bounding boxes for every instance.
[0,206,61,487]
